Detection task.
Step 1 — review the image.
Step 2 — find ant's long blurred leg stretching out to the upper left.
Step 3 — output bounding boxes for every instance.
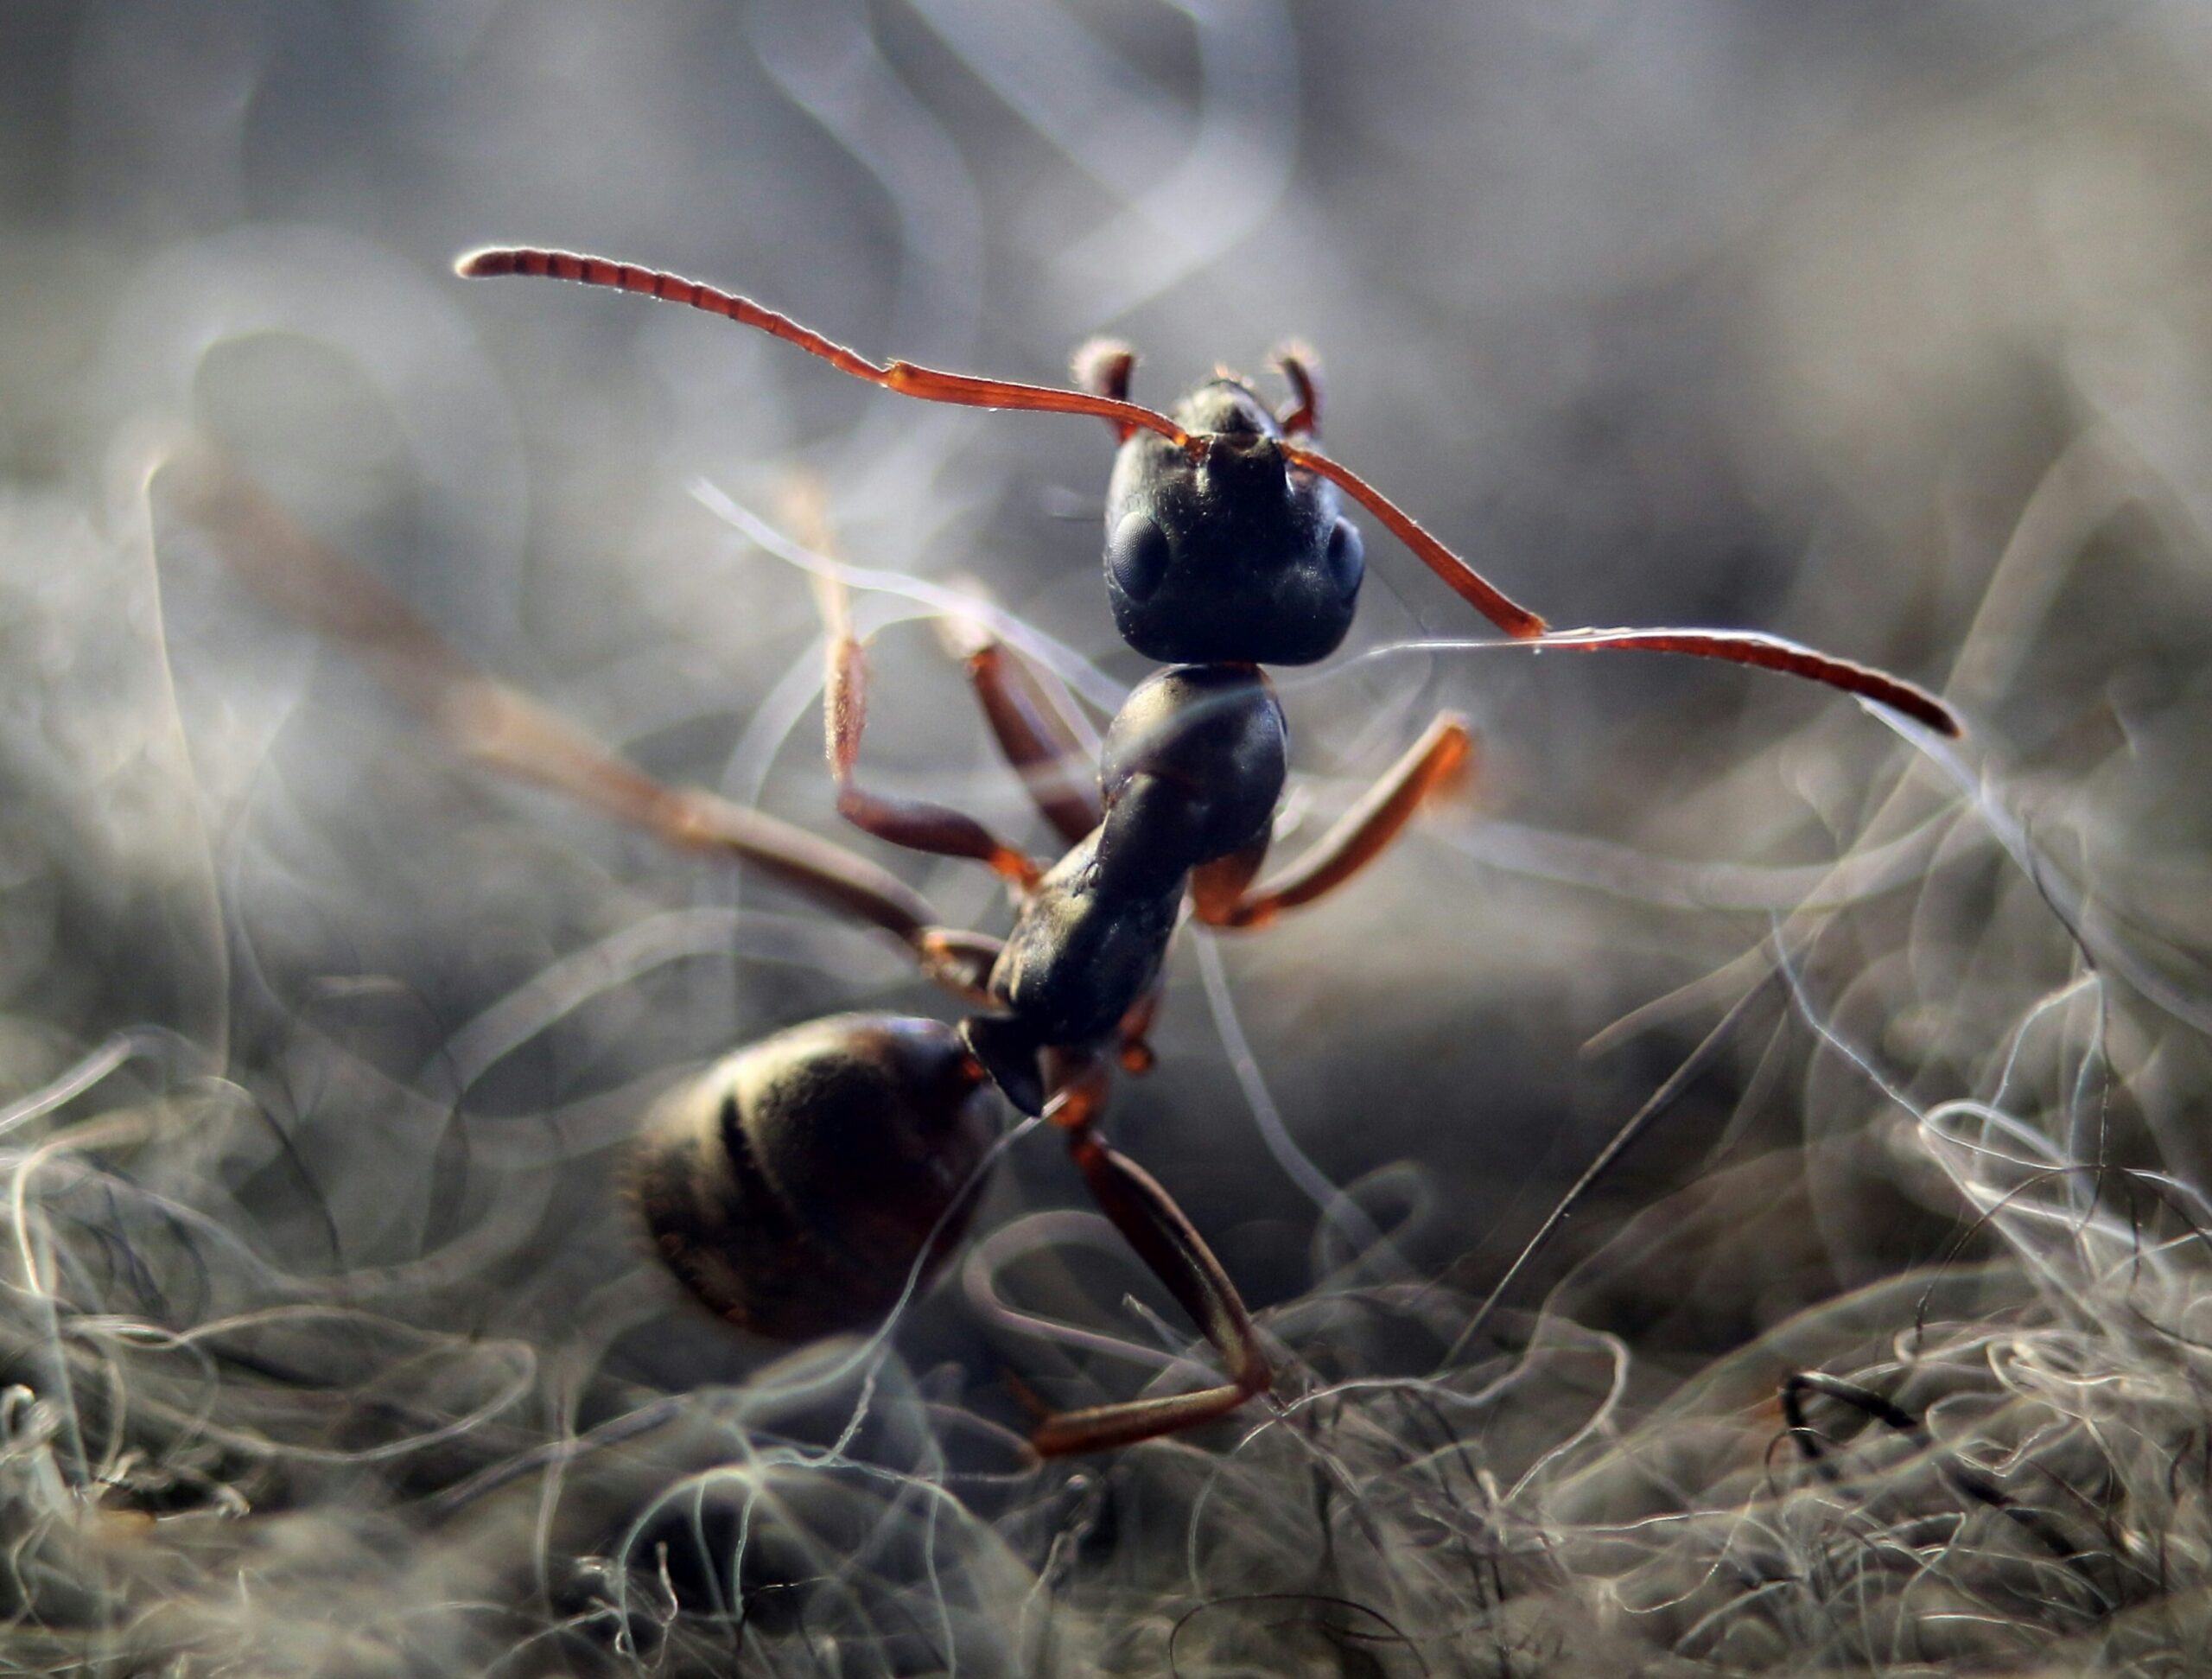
[162,445,998,1000]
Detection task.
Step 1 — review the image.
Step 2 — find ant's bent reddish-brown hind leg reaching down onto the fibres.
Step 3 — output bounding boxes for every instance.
[1031,1066,1274,1458]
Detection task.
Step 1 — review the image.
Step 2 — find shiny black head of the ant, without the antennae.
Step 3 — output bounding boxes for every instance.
[1106,378,1367,664]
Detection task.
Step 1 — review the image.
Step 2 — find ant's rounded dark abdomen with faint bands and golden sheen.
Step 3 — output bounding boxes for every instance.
[632,1015,998,1340]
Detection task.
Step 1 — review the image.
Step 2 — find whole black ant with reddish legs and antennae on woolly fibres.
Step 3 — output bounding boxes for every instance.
[181,248,1960,1455]
